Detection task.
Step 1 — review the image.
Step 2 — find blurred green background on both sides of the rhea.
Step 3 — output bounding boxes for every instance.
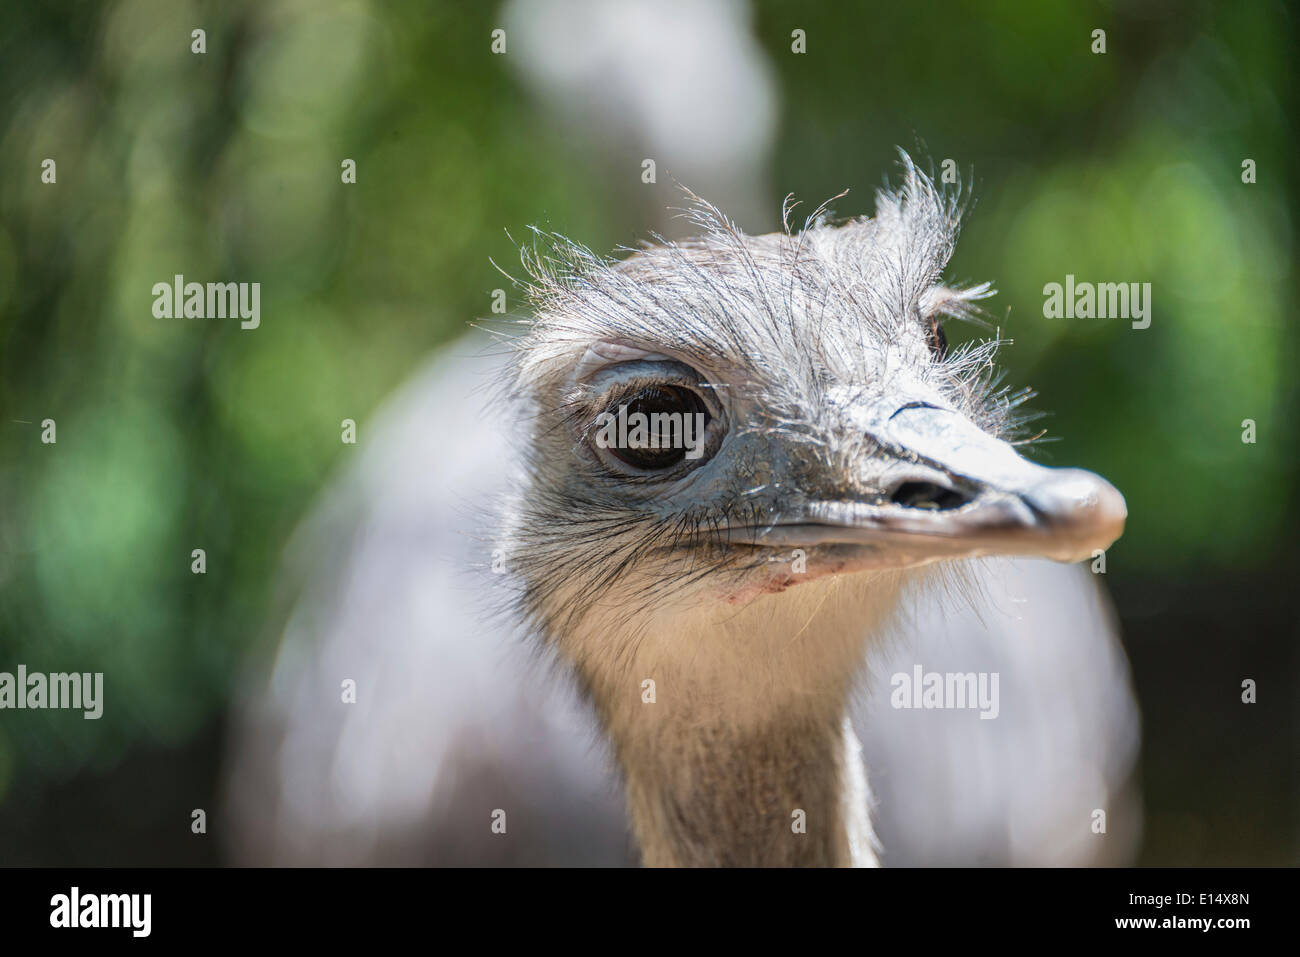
[0,0,1300,865]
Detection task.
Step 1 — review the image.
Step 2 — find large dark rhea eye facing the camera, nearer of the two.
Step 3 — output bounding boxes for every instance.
[594,385,710,472]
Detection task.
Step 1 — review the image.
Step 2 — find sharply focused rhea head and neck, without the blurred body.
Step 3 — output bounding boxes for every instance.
[501,164,1126,866]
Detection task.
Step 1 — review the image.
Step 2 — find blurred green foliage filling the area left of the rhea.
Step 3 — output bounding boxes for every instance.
[0,0,608,796]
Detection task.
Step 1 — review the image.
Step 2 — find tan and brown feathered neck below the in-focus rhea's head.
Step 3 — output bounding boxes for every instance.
[560,579,896,866]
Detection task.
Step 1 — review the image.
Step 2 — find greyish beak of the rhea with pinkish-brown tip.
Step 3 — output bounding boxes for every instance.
[753,402,1127,564]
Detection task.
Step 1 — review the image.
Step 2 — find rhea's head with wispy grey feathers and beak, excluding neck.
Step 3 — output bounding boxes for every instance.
[507,157,1126,647]
